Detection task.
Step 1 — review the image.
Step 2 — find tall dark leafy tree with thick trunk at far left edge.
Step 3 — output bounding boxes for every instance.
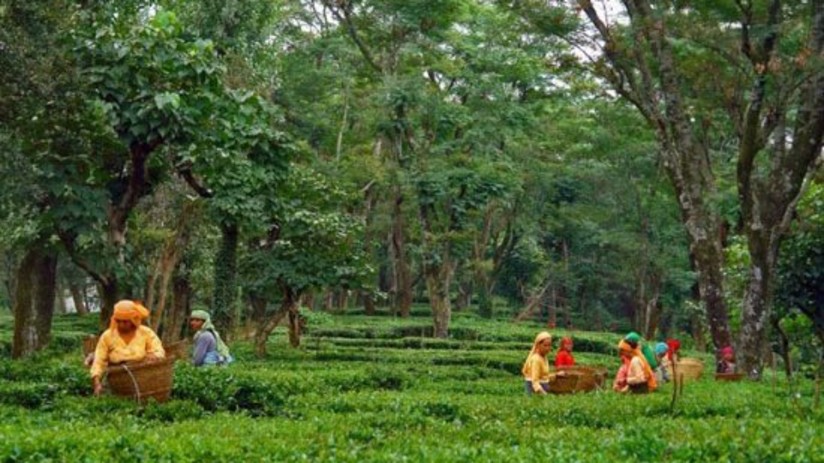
[0,1,107,357]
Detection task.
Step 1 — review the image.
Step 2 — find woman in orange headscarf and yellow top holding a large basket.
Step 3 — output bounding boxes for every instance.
[91,299,166,395]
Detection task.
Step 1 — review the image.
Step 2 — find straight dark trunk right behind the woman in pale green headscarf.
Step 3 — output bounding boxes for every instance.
[212,222,240,336]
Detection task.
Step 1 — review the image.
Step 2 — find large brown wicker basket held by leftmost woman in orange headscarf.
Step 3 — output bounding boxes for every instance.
[106,357,175,403]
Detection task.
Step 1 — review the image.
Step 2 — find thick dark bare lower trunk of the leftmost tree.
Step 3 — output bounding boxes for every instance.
[11,241,57,358]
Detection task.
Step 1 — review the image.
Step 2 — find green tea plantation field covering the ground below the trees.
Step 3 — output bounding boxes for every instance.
[0,312,824,463]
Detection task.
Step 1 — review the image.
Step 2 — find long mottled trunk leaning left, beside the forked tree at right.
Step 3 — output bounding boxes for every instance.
[578,0,731,354]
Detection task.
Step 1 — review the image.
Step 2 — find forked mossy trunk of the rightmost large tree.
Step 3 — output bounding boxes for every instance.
[737,1,824,379]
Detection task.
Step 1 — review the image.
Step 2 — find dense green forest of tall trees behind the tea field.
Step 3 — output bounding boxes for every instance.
[0,0,824,378]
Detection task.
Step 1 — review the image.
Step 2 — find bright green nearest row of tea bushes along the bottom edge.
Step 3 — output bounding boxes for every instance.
[0,383,824,462]
